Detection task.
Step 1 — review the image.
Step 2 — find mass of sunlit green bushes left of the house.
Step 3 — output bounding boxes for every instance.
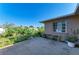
[0,23,44,47]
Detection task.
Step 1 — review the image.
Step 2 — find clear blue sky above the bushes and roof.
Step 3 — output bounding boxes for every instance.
[0,3,76,27]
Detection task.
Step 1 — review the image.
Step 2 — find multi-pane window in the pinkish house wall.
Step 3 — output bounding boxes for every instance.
[53,21,67,32]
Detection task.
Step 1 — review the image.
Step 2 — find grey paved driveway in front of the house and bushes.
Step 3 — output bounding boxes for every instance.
[0,37,79,55]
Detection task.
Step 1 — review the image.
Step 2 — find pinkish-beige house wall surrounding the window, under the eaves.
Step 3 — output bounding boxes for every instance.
[45,15,79,35]
